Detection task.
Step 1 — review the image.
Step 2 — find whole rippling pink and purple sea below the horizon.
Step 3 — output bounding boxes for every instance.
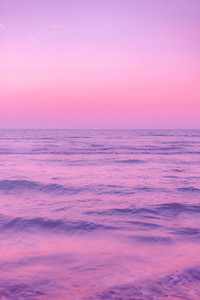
[0,130,200,300]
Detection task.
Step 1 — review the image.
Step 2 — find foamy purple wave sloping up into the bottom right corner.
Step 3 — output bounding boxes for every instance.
[84,266,200,300]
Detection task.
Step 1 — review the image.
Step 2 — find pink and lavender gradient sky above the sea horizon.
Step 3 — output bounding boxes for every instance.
[0,0,200,129]
